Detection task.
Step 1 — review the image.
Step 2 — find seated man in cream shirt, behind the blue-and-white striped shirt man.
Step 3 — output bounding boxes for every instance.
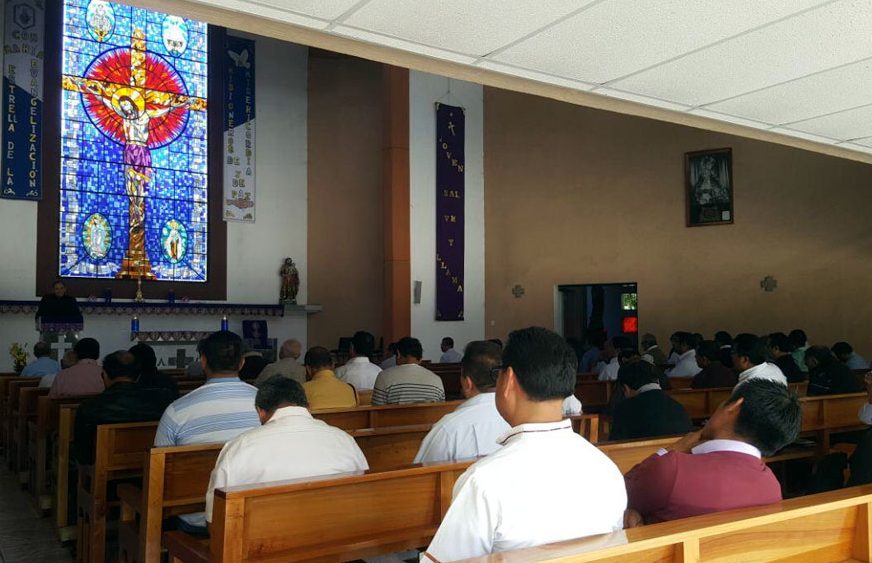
[206,376,369,522]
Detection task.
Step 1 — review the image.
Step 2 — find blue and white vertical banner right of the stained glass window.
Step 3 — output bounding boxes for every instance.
[223,35,256,223]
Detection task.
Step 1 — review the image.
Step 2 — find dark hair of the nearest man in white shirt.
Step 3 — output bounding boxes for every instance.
[503,327,578,401]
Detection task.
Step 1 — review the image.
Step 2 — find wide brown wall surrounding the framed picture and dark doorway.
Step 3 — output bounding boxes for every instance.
[484,88,872,358]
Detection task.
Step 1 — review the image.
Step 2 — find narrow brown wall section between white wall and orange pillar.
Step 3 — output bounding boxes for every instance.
[308,54,384,348]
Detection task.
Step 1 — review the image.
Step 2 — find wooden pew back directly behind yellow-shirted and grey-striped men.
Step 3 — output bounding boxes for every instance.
[312,401,462,430]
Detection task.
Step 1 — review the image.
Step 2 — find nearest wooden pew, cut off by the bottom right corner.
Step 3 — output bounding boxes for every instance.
[468,485,872,563]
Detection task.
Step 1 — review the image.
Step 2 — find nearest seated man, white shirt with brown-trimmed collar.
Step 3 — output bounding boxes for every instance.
[421,327,626,562]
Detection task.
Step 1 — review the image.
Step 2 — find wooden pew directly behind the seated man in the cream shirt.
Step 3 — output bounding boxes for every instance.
[164,461,472,563]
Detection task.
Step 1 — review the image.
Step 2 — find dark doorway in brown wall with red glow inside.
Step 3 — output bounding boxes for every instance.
[557,282,639,348]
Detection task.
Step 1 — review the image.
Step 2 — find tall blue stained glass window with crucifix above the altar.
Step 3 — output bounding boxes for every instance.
[59,0,208,282]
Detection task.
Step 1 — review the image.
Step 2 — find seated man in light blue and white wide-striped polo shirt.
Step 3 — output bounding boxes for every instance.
[154,330,260,533]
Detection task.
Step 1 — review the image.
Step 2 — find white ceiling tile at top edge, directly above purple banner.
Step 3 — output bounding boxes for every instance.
[344,0,593,56]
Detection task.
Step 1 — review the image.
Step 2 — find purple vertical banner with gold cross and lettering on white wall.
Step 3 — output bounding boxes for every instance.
[436,103,466,321]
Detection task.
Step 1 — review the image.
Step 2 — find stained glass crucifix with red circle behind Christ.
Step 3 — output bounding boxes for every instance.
[63,29,207,279]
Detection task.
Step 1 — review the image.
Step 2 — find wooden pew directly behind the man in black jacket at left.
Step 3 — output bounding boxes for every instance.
[76,421,157,563]
